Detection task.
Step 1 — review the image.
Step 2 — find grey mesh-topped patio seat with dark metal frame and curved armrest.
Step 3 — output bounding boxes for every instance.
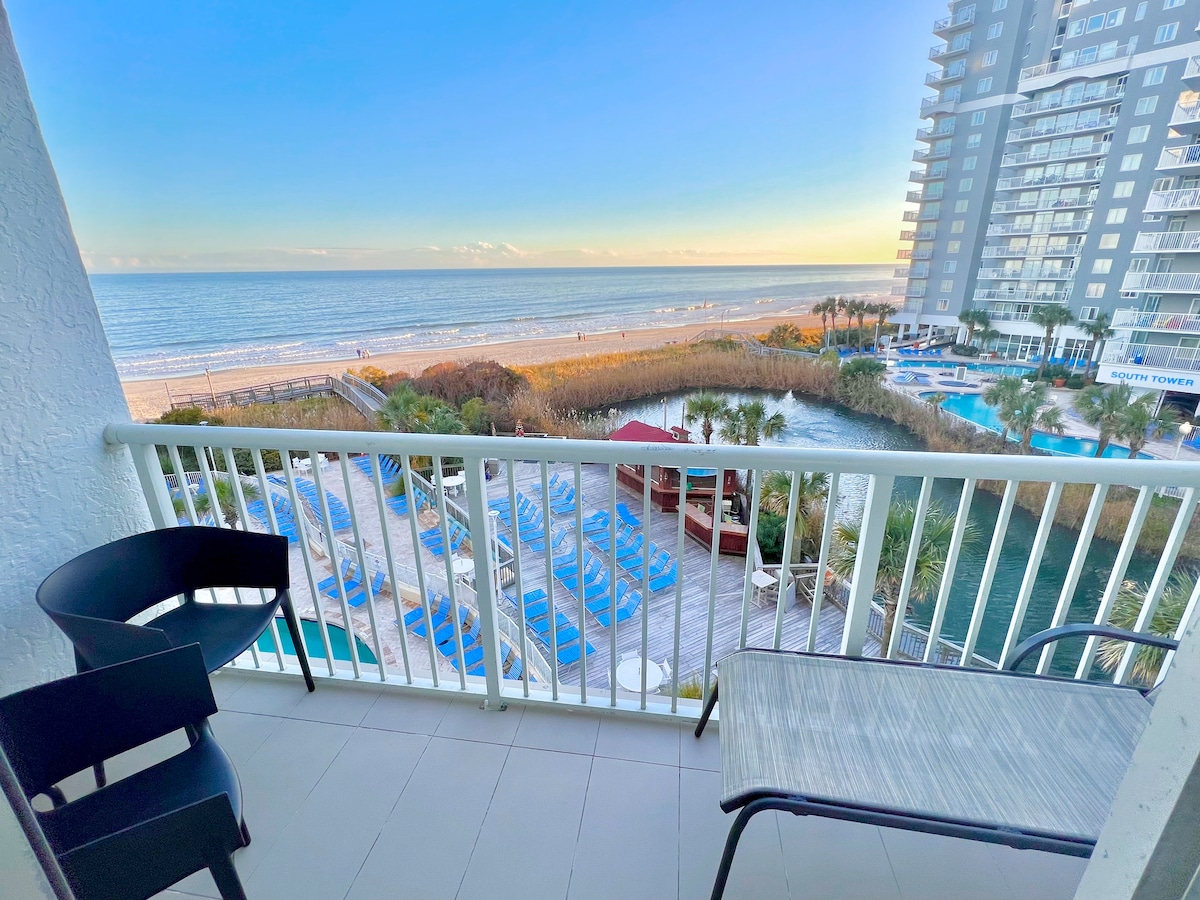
[696,623,1178,900]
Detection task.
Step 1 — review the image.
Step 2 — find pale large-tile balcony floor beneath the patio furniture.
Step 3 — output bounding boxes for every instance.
[142,673,1085,900]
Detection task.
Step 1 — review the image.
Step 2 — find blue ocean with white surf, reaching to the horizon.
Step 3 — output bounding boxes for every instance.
[91,265,892,379]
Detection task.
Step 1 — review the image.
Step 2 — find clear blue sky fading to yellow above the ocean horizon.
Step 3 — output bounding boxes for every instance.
[7,0,946,271]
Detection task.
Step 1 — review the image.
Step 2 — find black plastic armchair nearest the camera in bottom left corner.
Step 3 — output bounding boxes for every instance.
[0,644,250,900]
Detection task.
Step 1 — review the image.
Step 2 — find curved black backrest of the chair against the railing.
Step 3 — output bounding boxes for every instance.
[37,526,288,635]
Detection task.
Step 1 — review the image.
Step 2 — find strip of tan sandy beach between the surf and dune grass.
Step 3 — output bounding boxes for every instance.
[122,316,830,421]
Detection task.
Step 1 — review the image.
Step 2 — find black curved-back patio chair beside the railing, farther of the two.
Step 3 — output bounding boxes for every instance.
[37,526,314,785]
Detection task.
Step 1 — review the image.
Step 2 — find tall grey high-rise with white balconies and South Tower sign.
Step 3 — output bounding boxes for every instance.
[893,0,1200,412]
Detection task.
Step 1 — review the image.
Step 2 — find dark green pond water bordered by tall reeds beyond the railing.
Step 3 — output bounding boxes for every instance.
[617,391,1157,672]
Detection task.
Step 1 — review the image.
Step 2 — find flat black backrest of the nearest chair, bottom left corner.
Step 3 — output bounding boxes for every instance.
[0,643,217,799]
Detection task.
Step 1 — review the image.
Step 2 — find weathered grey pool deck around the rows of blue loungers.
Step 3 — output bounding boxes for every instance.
[268,462,844,691]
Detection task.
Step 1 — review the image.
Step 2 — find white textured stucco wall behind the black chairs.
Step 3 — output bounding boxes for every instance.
[0,6,150,896]
